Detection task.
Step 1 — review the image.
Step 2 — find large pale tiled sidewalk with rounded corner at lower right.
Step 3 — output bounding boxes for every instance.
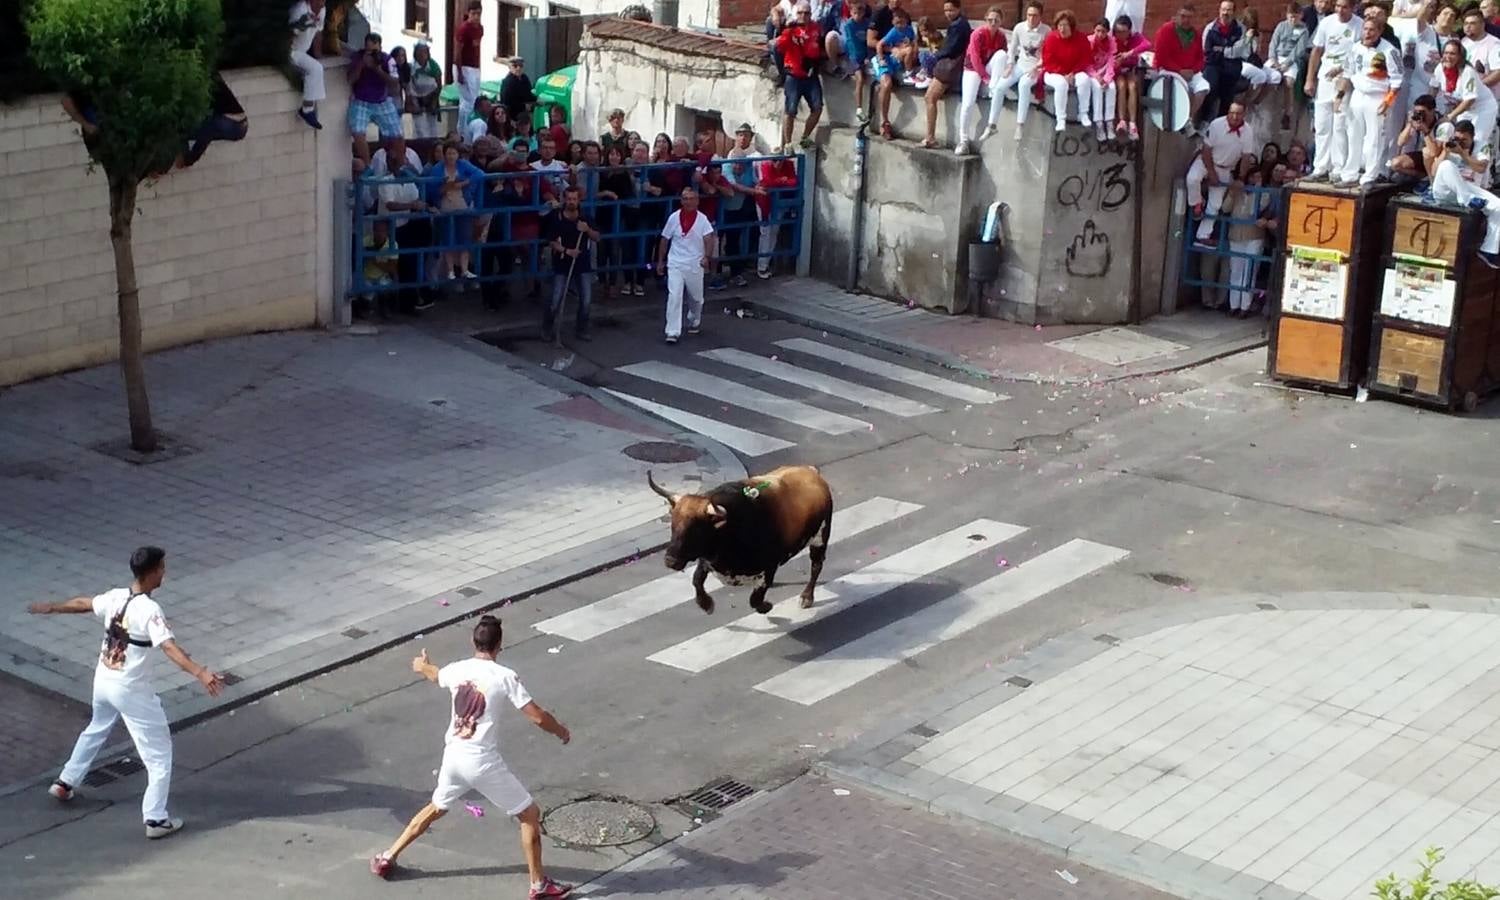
[819,593,1500,900]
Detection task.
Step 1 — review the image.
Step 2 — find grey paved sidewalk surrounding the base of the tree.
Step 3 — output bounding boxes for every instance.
[0,327,744,791]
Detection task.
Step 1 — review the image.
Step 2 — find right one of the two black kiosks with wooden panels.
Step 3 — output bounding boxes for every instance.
[1370,197,1500,411]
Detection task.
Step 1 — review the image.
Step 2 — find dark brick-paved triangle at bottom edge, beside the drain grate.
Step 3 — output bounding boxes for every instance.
[575,776,1169,900]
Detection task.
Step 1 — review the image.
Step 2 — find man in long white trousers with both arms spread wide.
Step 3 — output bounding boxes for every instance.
[27,548,224,839]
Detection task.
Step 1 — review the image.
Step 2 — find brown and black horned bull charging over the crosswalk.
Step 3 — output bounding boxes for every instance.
[647,465,834,614]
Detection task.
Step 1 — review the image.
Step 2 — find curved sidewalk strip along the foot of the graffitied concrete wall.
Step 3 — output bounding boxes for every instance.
[743,278,1266,384]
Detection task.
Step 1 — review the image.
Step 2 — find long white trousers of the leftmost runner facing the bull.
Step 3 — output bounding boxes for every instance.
[59,677,173,822]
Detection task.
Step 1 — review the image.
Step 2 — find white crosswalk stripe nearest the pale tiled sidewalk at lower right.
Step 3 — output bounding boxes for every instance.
[755,540,1130,707]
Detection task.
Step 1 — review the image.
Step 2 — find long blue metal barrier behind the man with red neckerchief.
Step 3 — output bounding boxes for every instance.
[347,155,807,300]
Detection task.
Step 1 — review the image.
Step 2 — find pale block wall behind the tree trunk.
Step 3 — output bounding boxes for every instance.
[0,62,350,386]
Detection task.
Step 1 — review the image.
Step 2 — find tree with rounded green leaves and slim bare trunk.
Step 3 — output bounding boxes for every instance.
[26,0,224,453]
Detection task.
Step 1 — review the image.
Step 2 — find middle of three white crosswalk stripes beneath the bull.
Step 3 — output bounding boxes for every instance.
[647,519,1026,672]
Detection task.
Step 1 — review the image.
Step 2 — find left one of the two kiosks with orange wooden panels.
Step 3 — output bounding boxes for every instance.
[1266,185,1397,393]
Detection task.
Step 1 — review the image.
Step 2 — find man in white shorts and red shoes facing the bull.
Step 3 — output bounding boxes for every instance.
[371,615,573,900]
